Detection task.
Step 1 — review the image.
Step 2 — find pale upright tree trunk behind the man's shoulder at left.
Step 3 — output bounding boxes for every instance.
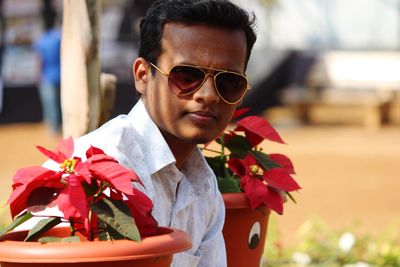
[61,0,100,137]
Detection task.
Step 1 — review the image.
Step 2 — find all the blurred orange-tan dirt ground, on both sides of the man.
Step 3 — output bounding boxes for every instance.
[0,124,400,248]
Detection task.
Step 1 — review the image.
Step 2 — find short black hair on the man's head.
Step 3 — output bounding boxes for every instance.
[139,0,257,70]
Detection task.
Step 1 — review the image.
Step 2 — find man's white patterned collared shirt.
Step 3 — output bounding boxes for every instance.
[75,100,226,267]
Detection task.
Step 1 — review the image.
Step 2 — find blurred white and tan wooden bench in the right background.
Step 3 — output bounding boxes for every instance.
[284,51,400,128]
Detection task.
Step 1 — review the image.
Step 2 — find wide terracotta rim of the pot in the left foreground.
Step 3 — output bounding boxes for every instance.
[0,227,192,263]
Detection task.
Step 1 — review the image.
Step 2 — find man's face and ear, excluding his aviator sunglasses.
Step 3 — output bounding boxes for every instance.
[134,23,246,148]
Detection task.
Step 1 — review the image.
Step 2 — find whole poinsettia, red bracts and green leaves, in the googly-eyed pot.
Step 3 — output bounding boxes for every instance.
[203,108,300,214]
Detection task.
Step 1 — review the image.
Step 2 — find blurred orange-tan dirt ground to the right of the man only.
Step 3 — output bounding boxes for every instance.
[266,123,400,247]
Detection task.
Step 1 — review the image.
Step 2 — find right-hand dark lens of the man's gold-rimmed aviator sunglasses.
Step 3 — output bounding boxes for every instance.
[215,72,247,103]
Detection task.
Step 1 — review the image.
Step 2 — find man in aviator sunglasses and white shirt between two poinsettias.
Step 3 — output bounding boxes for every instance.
[76,0,256,267]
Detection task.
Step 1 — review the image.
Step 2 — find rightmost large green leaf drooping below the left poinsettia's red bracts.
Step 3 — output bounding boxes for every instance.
[90,198,140,241]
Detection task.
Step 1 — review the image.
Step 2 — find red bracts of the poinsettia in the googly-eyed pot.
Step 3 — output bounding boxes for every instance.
[233,116,300,214]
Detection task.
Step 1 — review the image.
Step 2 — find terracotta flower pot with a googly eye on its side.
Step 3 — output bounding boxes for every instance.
[222,193,270,267]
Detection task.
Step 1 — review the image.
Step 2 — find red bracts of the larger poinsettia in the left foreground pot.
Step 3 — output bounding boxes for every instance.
[8,138,157,241]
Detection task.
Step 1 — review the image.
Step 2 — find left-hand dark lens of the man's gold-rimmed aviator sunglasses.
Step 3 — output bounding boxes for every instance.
[168,66,205,96]
